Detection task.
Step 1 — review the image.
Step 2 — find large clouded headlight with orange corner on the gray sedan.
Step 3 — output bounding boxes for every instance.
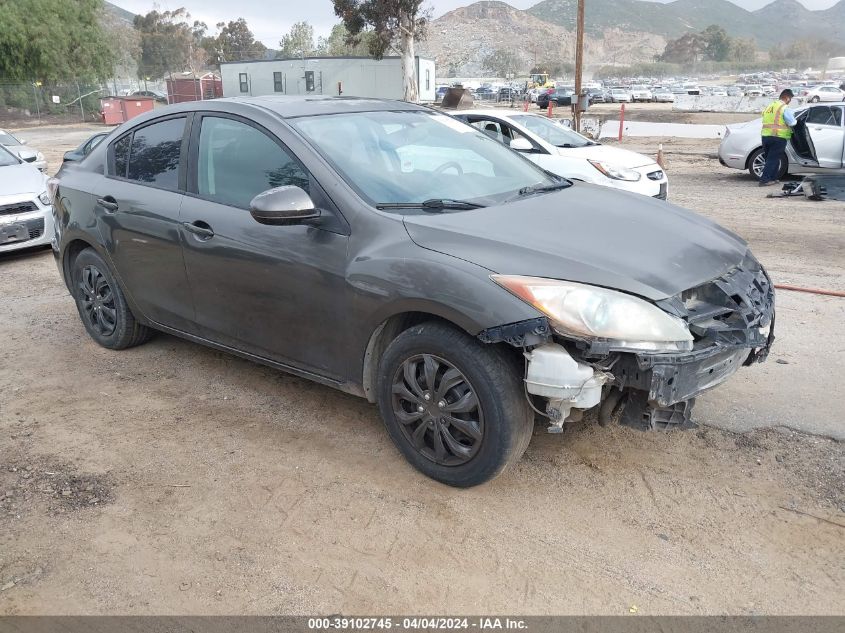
[491,275,693,352]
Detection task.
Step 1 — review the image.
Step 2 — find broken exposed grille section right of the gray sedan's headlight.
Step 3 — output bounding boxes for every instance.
[658,255,775,360]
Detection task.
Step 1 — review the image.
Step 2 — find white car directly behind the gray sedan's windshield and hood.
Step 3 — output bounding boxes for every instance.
[453,110,669,200]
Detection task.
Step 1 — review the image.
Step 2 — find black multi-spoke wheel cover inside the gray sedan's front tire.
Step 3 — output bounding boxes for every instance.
[392,354,484,466]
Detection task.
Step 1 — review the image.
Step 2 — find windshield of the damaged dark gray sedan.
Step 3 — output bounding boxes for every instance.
[290,110,557,205]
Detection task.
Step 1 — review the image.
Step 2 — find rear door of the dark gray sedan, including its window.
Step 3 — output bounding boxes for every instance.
[94,114,194,331]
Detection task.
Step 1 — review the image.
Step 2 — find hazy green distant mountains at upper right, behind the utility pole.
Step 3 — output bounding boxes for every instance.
[528,0,845,48]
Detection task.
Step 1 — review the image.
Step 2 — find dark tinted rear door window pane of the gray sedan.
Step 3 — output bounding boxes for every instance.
[127,117,185,189]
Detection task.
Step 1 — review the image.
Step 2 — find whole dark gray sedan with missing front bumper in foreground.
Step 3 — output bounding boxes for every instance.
[53,97,774,486]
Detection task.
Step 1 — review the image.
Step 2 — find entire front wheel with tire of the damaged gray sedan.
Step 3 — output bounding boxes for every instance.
[378,322,534,488]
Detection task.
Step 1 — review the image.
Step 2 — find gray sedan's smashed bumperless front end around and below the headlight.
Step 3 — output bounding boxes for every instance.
[482,252,775,432]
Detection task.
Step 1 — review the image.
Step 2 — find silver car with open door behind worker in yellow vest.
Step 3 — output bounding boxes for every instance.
[719,104,845,180]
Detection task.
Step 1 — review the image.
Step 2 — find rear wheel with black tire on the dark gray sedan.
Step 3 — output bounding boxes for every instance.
[71,248,152,349]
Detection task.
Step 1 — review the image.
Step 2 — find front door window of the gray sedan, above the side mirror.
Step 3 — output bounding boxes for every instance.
[197,116,309,209]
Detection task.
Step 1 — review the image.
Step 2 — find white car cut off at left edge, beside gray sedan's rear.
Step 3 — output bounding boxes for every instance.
[0,147,53,253]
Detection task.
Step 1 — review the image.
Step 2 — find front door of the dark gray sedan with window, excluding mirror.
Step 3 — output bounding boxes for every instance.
[181,114,348,378]
